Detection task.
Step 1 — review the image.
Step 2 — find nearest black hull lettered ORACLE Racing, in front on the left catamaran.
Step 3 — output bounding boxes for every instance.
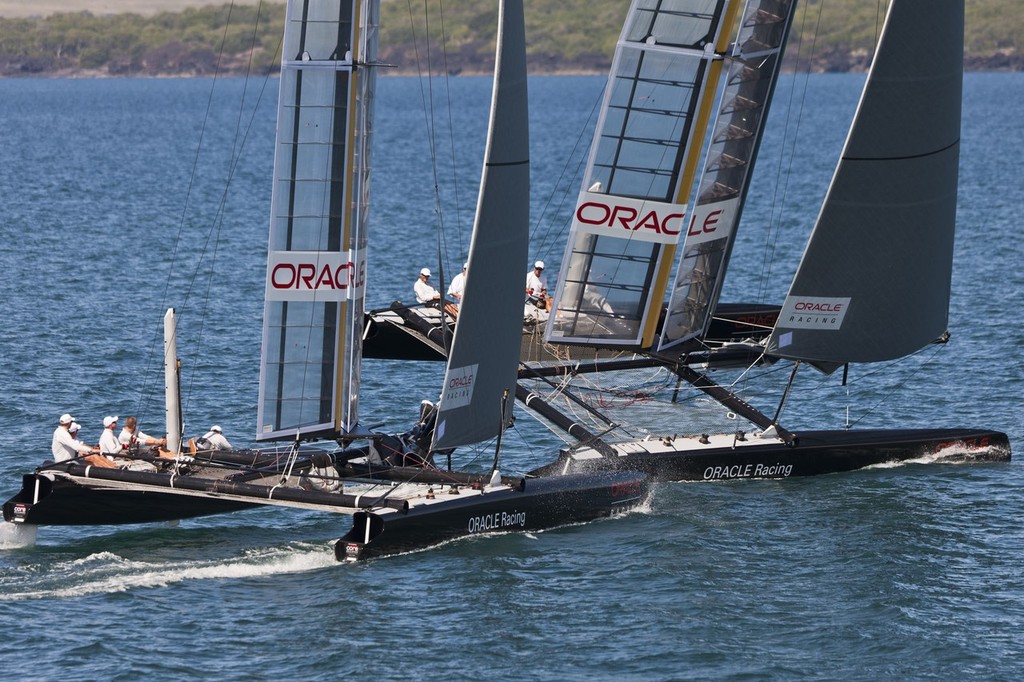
[335,471,648,561]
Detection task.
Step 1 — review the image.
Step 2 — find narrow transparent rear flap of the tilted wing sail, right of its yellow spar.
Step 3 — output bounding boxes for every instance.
[659,0,797,348]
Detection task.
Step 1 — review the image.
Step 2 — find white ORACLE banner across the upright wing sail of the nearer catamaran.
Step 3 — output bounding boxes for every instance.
[266,249,367,301]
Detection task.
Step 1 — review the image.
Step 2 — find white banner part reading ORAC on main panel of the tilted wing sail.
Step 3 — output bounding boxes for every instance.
[572,191,686,244]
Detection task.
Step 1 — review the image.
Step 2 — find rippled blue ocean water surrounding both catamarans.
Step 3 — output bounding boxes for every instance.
[0,74,1024,680]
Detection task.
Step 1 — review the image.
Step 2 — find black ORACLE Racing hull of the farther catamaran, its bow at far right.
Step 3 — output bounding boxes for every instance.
[531,429,1011,481]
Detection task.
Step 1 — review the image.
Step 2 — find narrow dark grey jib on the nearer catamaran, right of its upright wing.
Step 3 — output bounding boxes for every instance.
[431,0,529,450]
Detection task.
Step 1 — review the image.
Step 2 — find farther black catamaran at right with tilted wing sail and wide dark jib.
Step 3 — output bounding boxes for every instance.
[378,0,1010,480]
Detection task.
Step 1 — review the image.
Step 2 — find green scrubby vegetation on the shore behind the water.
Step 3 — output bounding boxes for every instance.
[0,0,1024,76]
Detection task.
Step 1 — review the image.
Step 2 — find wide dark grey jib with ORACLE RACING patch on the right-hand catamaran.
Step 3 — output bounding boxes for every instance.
[768,0,964,372]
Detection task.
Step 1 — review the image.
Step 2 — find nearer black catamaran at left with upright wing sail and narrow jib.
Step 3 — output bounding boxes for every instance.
[3,0,648,560]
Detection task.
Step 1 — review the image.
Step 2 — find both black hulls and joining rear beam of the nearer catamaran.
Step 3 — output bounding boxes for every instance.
[3,465,648,561]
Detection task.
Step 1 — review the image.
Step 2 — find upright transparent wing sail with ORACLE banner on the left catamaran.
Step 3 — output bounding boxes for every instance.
[256,0,379,440]
